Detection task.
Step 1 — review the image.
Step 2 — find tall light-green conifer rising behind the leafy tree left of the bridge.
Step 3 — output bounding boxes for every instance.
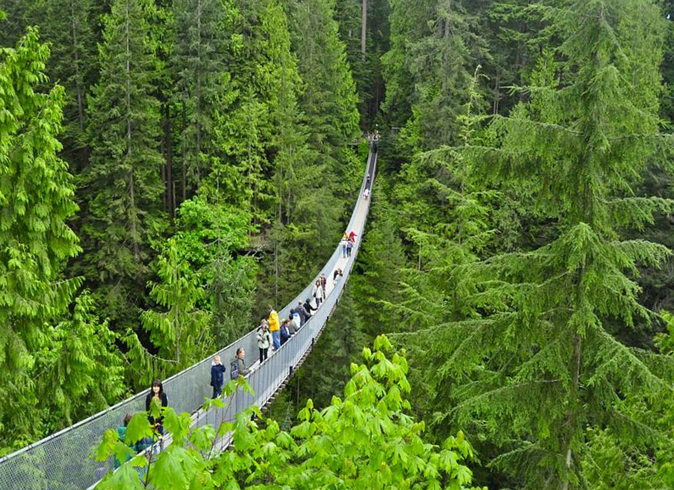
[205,0,282,226]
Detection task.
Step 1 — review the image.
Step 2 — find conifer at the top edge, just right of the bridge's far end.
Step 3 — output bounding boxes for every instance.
[383,0,486,150]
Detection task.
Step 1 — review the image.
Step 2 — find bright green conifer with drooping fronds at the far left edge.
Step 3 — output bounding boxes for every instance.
[0,29,81,446]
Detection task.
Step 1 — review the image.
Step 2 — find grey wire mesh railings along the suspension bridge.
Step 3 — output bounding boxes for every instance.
[0,145,377,490]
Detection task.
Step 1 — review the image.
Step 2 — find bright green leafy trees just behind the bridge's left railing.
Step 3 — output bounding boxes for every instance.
[127,197,256,386]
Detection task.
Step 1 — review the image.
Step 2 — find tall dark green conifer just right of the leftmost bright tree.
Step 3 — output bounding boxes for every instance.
[81,0,162,334]
